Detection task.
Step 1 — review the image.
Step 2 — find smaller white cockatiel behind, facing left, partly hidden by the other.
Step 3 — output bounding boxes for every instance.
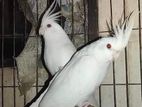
[39,0,76,75]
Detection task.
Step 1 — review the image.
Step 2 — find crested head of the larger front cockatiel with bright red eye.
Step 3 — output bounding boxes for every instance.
[91,13,134,61]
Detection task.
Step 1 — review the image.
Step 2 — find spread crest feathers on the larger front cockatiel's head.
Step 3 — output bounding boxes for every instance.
[109,12,134,50]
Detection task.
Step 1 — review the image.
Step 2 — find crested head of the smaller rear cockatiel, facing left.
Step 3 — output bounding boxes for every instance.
[39,0,61,36]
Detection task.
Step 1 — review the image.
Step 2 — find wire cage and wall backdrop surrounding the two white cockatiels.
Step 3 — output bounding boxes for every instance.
[0,0,142,107]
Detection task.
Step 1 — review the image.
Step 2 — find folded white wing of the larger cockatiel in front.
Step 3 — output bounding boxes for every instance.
[40,51,107,107]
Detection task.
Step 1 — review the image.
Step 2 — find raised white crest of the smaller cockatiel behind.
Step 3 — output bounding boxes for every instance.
[42,0,61,22]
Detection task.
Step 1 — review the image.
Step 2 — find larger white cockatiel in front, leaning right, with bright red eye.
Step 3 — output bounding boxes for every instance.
[35,14,133,107]
